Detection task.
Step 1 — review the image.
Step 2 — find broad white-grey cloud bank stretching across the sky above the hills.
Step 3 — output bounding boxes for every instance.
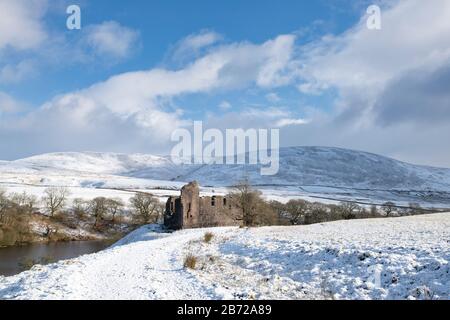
[0,0,450,166]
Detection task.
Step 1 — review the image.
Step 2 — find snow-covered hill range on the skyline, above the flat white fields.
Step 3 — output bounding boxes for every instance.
[0,147,450,191]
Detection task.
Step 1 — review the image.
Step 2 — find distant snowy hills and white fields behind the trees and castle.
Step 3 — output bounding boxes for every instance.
[0,147,450,208]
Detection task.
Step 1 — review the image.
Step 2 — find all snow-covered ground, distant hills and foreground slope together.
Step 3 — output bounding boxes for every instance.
[0,147,450,299]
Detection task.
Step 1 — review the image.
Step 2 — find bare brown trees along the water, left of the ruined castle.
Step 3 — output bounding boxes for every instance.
[0,187,164,246]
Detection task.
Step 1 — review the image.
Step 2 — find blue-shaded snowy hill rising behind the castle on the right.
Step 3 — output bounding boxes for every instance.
[177,147,450,190]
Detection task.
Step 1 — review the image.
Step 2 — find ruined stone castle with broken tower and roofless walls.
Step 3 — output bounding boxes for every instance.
[164,182,242,230]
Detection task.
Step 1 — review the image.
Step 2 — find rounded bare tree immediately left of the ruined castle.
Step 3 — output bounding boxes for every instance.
[130,192,164,223]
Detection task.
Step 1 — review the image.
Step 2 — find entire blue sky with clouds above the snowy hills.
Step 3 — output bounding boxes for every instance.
[0,0,450,167]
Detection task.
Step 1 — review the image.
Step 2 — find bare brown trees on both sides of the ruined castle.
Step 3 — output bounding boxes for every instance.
[0,180,442,246]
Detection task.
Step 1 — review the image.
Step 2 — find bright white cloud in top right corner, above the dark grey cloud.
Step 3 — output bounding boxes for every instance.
[299,0,450,119]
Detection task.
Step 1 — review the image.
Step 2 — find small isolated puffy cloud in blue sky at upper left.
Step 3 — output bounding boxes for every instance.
[84,21,139,58]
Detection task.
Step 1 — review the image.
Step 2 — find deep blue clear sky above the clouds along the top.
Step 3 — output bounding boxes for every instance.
[9,0,365,105]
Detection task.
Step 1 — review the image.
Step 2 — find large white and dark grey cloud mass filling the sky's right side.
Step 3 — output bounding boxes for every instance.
[284,0,450,167]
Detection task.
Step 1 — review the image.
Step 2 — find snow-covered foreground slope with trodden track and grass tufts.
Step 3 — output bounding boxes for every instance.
[0,213,450,299]
